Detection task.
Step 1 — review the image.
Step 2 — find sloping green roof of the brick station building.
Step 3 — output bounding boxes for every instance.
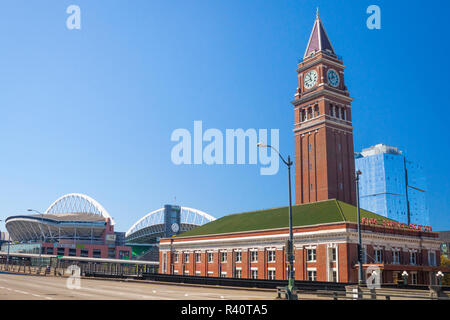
[177,199,390,237]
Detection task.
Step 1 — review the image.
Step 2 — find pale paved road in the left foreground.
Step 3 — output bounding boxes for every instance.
[0,273,276,300]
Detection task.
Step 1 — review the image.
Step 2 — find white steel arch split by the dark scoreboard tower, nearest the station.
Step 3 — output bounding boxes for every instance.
[125,207,216,237]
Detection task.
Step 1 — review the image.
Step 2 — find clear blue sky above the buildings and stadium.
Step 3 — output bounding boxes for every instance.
[0,0,450,231]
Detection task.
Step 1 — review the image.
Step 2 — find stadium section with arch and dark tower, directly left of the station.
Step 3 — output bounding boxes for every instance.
[125,205,216,261]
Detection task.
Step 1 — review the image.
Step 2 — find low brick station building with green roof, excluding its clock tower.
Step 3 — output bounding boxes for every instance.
[159,200,449,284]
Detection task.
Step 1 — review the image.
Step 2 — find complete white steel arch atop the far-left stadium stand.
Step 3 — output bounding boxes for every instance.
[45,193,115,225]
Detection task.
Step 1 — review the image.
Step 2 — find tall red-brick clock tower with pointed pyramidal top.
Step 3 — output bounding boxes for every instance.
[292,11,356,205]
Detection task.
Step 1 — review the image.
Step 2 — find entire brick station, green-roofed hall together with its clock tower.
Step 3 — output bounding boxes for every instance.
[159,12,450,284]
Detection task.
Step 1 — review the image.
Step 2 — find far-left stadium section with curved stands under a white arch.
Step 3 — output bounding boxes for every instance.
[5,193,131,259]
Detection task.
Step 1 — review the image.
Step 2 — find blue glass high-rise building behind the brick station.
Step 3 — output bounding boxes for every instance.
[355,144,430,225]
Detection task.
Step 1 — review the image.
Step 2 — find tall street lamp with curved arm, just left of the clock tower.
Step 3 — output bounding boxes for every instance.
[257,143,297,300]
